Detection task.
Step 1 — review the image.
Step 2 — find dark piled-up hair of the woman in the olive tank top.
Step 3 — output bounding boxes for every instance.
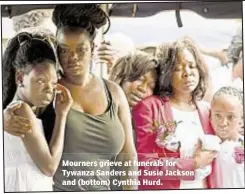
[52,4,110,40]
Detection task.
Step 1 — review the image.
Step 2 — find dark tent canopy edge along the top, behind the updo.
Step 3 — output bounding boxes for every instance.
[1,0,242,20]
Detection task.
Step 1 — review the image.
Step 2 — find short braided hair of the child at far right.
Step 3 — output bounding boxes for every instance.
[213,86,243,104]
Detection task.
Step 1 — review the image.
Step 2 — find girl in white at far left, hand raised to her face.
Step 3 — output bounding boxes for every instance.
[3,32,72,192]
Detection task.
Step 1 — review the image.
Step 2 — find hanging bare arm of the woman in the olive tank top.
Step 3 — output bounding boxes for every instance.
[110,82,138,190]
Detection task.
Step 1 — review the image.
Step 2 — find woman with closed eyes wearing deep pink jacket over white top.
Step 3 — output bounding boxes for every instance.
[132,40,215,190]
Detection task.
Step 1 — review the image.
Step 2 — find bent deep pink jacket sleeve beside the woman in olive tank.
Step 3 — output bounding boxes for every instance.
[132,101,194,189]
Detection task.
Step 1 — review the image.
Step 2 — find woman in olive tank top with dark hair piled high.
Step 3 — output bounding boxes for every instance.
[3,4,137,191]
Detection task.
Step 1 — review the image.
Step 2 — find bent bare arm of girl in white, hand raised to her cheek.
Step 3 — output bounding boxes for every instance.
[11,86,72,176]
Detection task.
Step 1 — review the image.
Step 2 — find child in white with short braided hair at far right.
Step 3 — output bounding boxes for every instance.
[211,87,244,188]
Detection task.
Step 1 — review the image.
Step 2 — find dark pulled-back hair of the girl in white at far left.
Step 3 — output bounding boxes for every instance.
[2,32,56,108]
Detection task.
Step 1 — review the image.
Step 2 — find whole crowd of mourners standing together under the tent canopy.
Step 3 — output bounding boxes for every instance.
[2,4,244,192]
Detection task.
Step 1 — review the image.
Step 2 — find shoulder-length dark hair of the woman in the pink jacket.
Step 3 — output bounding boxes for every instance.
[154,39,208,103]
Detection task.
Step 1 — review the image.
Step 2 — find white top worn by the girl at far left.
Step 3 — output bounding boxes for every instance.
[4,119,53,192]
